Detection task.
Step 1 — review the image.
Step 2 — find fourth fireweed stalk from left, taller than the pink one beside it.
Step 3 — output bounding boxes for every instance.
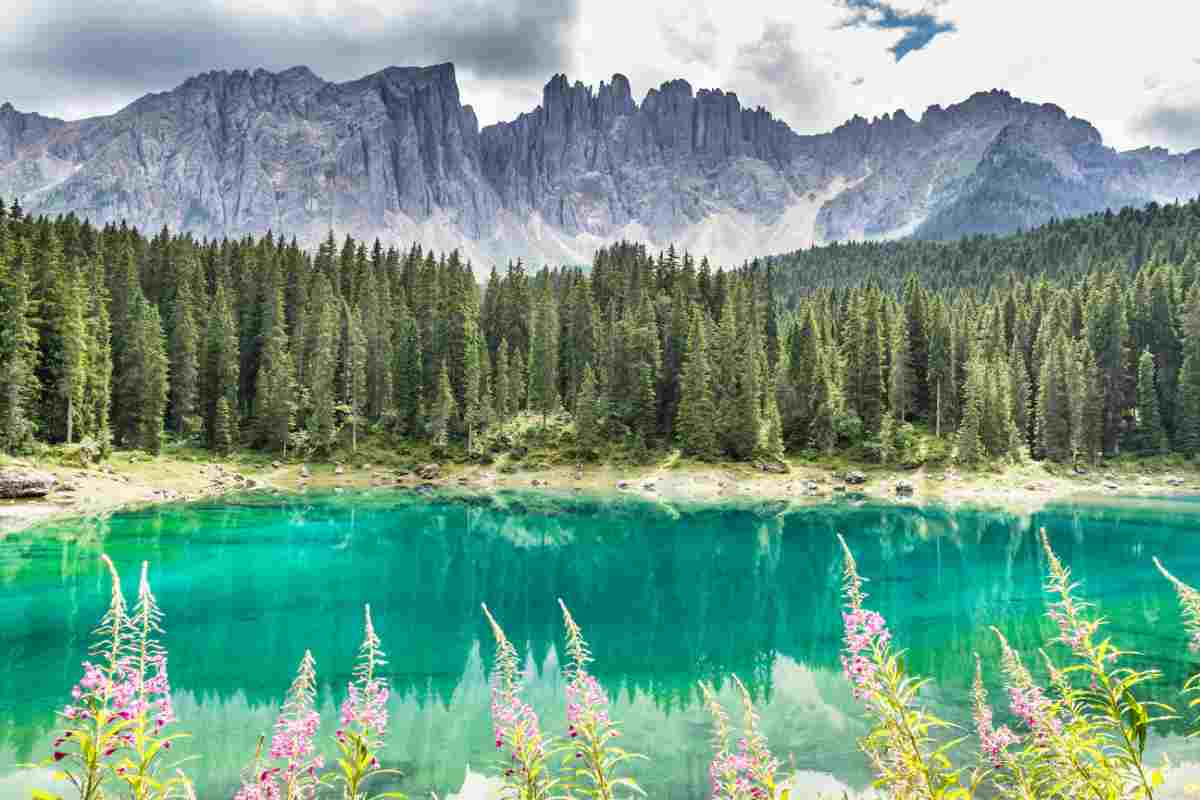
[322,606,404,800]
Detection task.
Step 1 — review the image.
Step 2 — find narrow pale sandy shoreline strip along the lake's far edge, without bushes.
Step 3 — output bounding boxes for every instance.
[0,453,1200,539]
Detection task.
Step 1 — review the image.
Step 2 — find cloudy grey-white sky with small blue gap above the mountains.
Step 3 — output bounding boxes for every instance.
[0,0,1200,150]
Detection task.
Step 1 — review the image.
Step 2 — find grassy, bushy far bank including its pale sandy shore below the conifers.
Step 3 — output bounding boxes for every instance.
[0,416,1200,529]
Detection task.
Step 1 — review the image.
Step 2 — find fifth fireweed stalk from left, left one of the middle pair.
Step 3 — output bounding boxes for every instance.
[484,604,558,800]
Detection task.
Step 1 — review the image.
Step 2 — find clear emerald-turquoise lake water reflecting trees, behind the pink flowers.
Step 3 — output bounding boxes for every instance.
[0,493,1200,800]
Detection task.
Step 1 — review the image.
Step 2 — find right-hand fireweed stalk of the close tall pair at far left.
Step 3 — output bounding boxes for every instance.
[113,561,187,800]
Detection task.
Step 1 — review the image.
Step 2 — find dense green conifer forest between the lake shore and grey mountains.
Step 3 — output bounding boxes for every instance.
[0,194,1200,463]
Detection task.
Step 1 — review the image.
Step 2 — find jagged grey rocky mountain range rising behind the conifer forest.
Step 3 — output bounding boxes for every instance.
[0,64,1200,266]
